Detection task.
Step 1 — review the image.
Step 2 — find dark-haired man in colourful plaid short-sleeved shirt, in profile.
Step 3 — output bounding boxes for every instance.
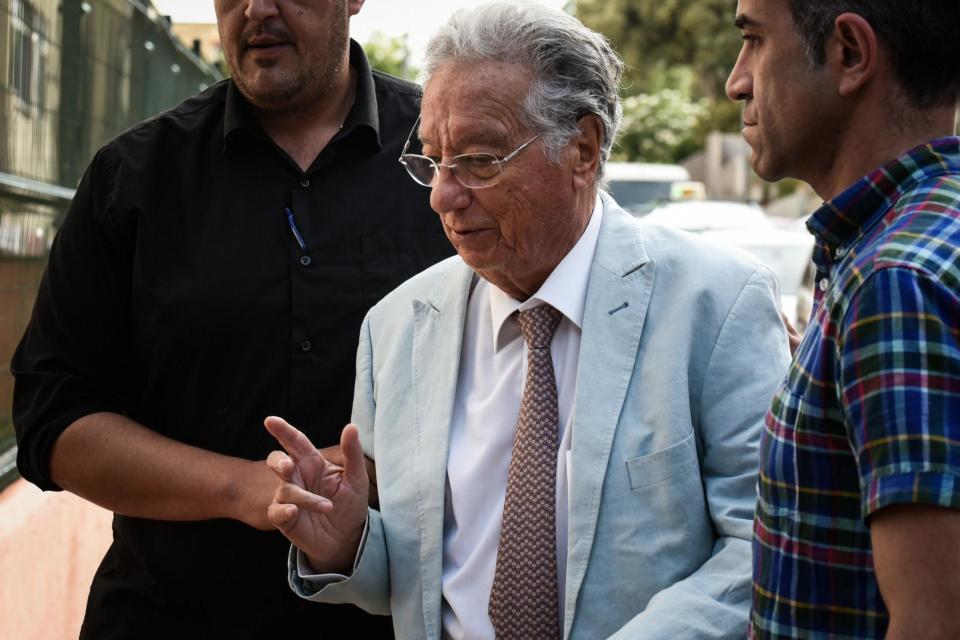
[727,0,960,640]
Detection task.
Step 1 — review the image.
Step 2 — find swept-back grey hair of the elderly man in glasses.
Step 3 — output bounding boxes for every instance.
[423,2,623,183]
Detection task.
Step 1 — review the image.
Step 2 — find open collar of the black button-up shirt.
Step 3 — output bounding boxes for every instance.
[223,38,381,151]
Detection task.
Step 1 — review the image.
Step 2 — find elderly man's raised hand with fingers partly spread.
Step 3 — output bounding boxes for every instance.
[264,417,369,573]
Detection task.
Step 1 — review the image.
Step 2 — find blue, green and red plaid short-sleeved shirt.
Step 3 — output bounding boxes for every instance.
[750,138,960,638]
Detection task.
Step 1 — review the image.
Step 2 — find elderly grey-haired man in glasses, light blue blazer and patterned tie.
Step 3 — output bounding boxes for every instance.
[267,3,788,640]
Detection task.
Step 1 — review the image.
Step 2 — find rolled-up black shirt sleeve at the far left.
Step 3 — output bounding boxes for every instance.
[10,148,133,490]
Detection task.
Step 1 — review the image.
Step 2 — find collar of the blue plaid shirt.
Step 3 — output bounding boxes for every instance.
[807,137,960,267]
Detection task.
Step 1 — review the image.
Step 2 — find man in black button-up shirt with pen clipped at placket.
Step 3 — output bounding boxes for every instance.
[12,0,452,640]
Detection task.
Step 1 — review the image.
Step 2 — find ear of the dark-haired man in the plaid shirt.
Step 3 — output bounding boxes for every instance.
[826,13,880,97]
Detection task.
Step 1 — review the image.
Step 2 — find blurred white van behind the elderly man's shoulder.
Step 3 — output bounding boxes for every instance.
[606,162,704,215]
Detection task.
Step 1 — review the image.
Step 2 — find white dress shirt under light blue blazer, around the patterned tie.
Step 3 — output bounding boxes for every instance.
[442,197,603,640]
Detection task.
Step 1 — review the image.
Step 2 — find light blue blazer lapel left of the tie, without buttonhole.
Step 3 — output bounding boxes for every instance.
[410,263,474,638]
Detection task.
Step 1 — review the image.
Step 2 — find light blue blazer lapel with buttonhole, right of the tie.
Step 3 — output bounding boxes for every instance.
[564,195,656,635]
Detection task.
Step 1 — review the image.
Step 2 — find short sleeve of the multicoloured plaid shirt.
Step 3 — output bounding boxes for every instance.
[838,267,960,519]
